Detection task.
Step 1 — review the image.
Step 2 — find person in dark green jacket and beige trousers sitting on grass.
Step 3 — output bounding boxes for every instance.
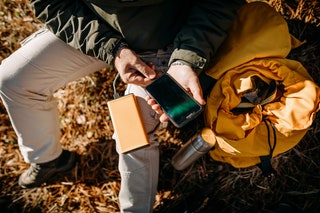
[0,0,246,212]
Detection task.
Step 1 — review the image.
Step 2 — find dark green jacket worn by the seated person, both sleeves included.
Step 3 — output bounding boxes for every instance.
[31,0,245,68]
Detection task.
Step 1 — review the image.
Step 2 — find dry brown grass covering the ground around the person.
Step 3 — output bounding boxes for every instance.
[0,0,320,212]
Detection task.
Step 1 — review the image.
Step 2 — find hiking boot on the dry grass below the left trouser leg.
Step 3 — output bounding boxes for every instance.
[18,150,75,188]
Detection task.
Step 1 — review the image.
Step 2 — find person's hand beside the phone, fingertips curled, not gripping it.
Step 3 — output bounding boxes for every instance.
[114,48,156,86]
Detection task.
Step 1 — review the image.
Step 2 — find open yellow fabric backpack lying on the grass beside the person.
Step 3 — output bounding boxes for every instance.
[204,2,320,176]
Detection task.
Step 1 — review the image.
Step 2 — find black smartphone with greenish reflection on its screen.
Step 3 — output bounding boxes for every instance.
[146,74,203,128]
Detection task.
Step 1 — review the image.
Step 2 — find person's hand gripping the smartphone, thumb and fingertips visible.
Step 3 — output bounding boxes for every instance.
[146,65,206,122]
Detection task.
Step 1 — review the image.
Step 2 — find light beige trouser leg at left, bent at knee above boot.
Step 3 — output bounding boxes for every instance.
[0,29,107,163]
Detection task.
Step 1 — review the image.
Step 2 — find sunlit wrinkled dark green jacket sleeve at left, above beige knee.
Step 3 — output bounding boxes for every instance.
[30,0,122,64]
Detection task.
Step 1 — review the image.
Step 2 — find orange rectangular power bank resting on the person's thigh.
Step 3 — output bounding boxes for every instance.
[108,94,149,153]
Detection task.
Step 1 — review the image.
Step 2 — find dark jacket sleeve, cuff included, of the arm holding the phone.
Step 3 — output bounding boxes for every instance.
[169,0,246,70]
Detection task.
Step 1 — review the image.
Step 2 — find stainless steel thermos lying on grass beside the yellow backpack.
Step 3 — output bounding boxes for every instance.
[171,128,216,170]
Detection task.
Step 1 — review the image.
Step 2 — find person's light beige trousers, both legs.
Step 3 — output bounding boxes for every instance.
[0,29,172,212]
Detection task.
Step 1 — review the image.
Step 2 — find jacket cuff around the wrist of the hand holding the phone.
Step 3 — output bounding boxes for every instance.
[169,49,207,73]
